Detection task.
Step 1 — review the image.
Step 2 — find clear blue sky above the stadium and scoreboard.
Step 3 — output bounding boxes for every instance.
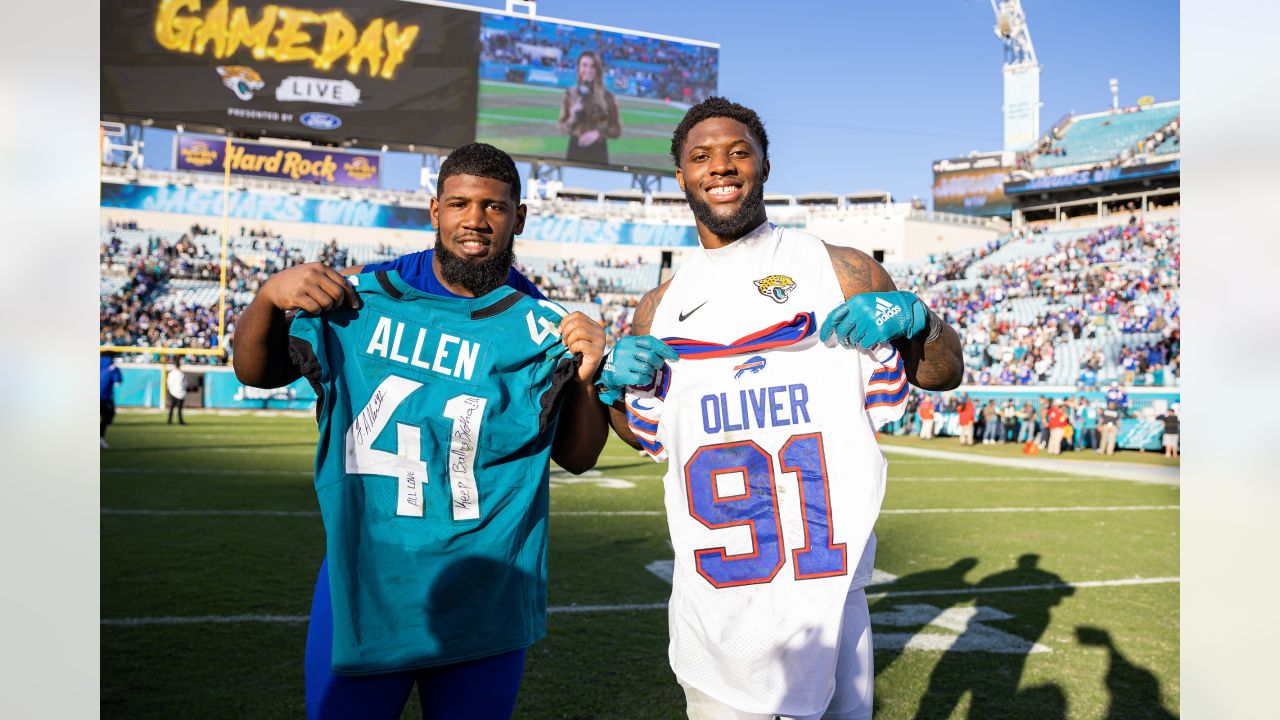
[140,0,1180,204]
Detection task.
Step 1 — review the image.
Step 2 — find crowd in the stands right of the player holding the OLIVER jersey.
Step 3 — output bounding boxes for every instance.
[906,219,1181,386]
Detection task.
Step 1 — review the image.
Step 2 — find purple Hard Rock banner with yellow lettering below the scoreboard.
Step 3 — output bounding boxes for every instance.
[174,135,381,187]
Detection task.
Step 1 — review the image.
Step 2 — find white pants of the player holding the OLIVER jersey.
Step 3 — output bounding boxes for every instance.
[680,589,876,720]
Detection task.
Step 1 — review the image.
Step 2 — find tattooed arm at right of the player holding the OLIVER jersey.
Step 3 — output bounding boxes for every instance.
[824,245,964,391]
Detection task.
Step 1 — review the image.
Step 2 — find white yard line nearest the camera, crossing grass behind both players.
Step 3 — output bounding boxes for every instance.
[101,578,1181,628]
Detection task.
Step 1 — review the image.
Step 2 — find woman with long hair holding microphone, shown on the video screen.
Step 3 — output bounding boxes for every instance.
[559,50,622,165]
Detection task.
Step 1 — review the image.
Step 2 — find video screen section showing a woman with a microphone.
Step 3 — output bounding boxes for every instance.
[476,13,719,172]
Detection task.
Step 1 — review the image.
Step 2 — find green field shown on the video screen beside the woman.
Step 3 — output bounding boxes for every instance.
[476,81,685,172]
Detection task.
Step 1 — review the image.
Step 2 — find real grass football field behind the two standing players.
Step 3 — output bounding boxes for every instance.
[101,411,1179,719]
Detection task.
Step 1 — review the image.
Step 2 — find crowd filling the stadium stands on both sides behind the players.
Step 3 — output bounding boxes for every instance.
[100,218,1180,389]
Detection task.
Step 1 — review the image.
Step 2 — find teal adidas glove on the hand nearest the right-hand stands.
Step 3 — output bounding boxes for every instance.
[818,291,929,350]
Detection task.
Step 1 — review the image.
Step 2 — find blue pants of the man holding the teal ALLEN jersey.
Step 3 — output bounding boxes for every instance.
[306,557,525,720]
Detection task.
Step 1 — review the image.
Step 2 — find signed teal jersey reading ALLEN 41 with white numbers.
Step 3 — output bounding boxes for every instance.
[289,272,577,674]
